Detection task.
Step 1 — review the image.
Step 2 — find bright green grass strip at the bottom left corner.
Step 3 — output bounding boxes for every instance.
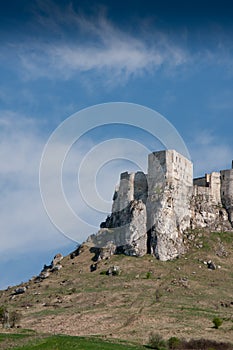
[0,334,143,350]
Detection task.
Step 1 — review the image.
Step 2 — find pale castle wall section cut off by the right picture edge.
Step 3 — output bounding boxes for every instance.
[220,169,233,225]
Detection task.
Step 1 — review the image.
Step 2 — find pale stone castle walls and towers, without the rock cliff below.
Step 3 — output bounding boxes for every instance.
[112,150,233,212]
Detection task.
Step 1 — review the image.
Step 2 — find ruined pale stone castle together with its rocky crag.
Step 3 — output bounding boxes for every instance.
[88,150,233,261]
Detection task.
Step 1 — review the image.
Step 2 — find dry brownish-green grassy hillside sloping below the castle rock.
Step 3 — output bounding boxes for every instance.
[0,231,233,349]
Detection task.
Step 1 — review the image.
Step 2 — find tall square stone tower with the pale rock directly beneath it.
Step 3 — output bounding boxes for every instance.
[147,150,193,260]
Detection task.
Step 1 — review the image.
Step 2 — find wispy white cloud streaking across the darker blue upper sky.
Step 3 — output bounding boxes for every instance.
[4,1,232,86]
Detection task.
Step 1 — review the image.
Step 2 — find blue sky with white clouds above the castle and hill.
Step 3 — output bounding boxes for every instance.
[0,0,233,289]
